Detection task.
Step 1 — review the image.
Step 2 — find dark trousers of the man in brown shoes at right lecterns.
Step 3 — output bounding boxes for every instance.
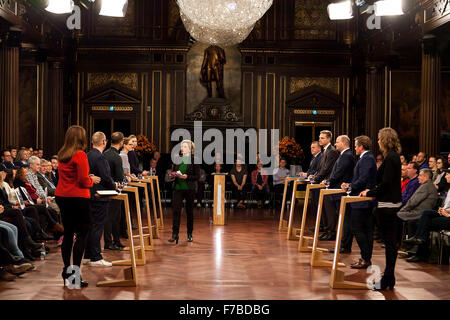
[350,208,374,261]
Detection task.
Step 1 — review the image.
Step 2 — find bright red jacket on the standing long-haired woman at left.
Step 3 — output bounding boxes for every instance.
[55,150,94,198]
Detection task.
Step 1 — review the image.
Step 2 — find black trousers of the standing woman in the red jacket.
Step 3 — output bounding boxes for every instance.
[55,197,92,268]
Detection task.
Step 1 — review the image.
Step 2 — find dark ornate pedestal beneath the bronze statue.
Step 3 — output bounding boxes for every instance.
[185,98,242,122]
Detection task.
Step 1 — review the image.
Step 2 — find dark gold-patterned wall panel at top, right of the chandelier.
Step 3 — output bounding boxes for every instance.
[295,0,336,40]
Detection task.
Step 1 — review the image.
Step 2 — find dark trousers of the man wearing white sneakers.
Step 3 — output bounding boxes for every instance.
[84,201,109,261]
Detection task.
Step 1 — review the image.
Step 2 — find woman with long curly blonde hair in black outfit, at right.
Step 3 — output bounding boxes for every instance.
[360,128,402,290]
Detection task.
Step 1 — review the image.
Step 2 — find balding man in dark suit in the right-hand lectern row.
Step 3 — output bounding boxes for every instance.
[319,135,355,240]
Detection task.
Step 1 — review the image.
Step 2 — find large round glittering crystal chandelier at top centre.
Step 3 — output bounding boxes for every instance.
[177,0,273,47]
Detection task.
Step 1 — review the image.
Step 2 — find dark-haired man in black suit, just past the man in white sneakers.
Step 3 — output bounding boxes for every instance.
[103,132,125,250]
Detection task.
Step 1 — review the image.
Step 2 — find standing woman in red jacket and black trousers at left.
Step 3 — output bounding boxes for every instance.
[55,126,100,287]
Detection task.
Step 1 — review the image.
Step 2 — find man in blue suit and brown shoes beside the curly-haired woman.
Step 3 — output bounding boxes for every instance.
[341,136,377,269]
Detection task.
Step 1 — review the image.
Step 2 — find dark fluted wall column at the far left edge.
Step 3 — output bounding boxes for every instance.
[0,37,19,148]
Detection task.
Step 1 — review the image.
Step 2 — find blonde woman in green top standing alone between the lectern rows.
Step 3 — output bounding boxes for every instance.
[169,140,200,244]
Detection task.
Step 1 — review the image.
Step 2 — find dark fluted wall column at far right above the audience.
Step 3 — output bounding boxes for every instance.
[418,35,441,155]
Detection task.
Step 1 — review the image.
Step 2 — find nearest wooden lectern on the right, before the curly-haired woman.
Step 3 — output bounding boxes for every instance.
[330,196,375,289]
